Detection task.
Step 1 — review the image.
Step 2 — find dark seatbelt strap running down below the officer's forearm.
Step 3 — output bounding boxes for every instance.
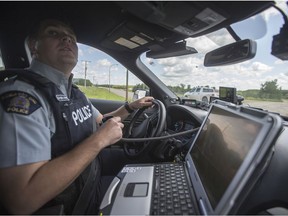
[72,158,99,215]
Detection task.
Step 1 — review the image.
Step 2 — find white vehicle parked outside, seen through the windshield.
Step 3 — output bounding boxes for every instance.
[184,86,219,103]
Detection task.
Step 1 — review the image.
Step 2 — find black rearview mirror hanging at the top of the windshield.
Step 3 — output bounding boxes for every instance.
[204,39,257,67]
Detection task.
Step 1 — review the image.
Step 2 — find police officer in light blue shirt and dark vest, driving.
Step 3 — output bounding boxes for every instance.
[0,20,153,214]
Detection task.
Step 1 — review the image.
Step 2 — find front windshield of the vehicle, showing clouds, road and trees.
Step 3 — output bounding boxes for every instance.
[141,2,288,116]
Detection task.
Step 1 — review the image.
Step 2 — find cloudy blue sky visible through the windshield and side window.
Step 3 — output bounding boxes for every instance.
[73,1,288,90]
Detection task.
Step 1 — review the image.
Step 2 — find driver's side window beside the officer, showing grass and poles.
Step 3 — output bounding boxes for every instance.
[73,43,143,102]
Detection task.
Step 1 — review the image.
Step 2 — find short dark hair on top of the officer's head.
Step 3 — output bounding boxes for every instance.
[28,19,76,39]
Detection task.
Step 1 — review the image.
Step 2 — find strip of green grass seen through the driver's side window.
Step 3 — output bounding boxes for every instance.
[78,86,125,101]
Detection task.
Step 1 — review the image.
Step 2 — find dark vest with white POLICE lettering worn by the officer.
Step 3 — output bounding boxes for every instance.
[0,69,96,214]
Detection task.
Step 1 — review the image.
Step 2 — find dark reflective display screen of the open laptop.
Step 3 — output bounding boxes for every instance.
[190,106,262,208]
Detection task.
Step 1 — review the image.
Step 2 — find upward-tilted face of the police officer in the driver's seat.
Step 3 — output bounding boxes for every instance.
[34,25,78,74]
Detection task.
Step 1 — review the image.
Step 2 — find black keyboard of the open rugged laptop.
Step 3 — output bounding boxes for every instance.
[151,163,195,215]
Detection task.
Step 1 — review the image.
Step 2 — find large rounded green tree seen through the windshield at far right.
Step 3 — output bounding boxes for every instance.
[259,79,282,100]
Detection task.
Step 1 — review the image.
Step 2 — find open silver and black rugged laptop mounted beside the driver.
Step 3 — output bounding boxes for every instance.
[100,101,282,215]
